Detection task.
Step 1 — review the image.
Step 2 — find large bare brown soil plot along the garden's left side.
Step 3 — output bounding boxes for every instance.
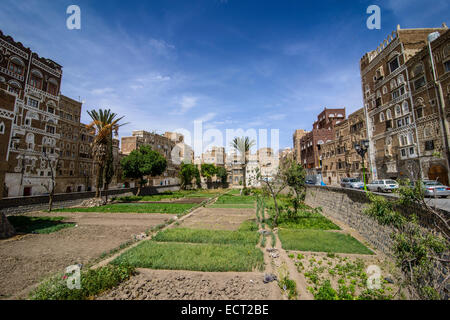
[0,213,174,299]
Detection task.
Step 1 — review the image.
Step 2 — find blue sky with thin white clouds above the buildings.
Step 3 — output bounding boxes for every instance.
[0,0,450,152]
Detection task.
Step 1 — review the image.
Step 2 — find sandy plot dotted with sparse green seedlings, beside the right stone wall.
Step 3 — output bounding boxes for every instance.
[288,251,398,300]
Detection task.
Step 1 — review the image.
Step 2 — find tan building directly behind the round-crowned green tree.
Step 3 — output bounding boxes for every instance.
[122,130,180,186]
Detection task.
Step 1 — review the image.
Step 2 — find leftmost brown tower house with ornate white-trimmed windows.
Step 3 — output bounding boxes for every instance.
[0,31,62,197]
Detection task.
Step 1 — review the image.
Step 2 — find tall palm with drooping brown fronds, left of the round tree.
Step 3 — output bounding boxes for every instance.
[87,109,125,198]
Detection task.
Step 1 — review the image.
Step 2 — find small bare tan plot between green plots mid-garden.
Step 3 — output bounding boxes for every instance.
[181,208,256,230]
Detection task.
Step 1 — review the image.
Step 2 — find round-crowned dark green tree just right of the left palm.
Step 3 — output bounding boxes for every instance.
[120,146,167,195]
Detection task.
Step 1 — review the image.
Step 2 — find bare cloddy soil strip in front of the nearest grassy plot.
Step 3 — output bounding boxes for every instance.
[97,269,281,300]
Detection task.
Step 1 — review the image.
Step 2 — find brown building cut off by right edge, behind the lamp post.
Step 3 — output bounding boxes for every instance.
[406,30,450,185]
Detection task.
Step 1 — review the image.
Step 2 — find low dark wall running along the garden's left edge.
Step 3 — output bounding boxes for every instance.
[0,185,180,216]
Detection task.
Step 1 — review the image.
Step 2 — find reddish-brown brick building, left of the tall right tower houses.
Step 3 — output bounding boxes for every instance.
[300,108,345,175]
